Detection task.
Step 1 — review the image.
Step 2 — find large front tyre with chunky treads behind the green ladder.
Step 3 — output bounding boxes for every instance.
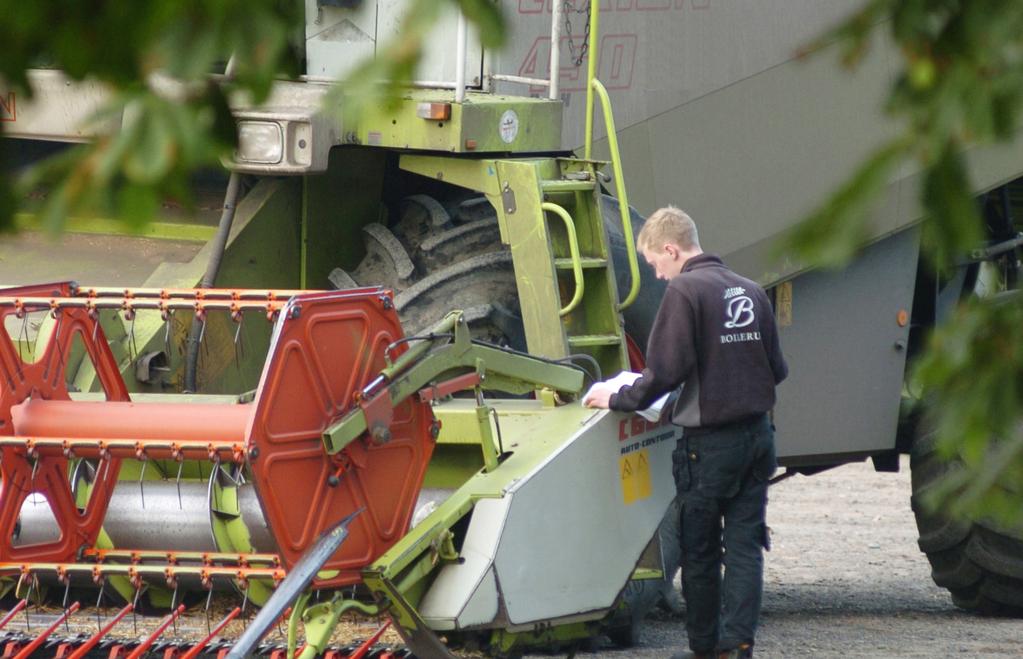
[330,189,680,646]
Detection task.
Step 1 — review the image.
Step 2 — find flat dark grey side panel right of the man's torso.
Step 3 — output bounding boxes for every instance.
[774,229,920,465]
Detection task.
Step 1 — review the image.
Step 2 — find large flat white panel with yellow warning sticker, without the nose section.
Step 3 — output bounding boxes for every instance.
[495,410,677,624]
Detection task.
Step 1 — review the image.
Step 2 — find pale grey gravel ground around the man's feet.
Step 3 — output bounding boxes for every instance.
[572,459,1023,659]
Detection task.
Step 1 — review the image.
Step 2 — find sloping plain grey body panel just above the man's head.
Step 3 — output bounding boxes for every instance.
[597,26,907,261]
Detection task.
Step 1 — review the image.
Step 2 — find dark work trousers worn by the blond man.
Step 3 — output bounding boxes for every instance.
[673,414,777,652]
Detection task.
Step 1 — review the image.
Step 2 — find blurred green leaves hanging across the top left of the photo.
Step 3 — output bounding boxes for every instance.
[0,0,503,231]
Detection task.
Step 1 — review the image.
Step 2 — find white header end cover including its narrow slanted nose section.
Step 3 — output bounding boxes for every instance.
[419,410,677,630]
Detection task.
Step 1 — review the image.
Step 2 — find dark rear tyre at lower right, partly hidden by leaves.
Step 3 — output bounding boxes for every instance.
[909,435,1023,617]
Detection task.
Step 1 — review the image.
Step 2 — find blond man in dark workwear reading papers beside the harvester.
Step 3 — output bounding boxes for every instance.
[584,206,788,659]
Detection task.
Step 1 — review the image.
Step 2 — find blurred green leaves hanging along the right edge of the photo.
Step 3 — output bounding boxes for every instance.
[787,0,1023,523]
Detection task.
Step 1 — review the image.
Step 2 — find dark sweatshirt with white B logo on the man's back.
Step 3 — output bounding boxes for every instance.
[610,254,789,429]
